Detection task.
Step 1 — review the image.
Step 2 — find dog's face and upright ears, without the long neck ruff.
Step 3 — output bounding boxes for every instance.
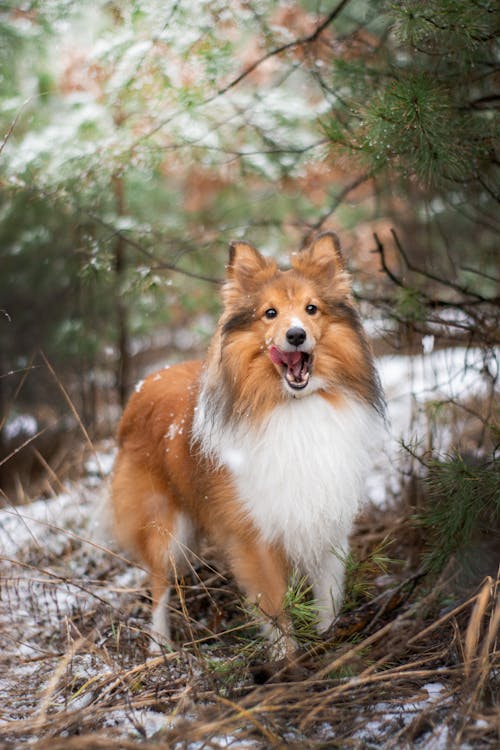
[221,233,362,397]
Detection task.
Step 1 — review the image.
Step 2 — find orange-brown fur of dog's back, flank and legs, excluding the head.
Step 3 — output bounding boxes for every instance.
[112,362,288,648]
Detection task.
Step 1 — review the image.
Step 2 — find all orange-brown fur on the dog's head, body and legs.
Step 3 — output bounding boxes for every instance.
[112,235,382,650]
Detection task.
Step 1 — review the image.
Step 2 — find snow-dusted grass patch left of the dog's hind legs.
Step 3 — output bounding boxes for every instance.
[0,454,152,746]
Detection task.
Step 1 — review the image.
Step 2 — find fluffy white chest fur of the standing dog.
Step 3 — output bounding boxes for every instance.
[196,394,380,571]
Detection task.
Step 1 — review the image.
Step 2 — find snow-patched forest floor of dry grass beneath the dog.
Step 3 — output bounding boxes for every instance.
[0,355,500,750]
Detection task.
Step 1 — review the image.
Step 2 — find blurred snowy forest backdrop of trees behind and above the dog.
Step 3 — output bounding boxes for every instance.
[0,0,499,506]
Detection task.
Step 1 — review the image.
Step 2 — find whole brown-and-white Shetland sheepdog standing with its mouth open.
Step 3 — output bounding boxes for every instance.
[112,233,384,656]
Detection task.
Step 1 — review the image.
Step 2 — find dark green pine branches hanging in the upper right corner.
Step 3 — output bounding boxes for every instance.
[322,0,500,300]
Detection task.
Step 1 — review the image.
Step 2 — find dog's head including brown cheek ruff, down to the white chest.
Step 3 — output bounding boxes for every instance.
[206,233,383,419]
